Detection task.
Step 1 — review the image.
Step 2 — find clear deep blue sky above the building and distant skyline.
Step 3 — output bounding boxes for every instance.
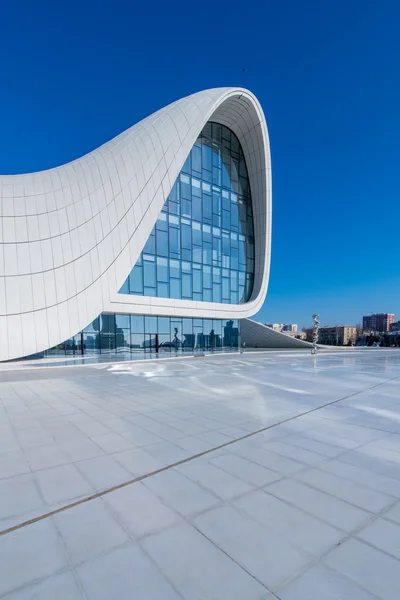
[0,0,400,325]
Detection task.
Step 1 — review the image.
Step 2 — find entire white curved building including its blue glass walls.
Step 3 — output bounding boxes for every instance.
[0,88,271,360]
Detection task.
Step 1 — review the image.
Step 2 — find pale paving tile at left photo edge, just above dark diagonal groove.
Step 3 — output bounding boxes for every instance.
[0,475,46,519]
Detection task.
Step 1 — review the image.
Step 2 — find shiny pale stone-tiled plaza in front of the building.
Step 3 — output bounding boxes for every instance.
[0,349,400,600]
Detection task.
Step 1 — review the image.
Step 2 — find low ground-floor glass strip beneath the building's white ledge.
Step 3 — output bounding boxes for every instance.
[44,314,240,356]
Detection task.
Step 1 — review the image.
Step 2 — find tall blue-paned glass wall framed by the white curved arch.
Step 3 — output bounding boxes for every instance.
[120,123,254,304]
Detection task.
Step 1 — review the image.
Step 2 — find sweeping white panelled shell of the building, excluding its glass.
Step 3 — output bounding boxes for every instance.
[0,88,271,360]
